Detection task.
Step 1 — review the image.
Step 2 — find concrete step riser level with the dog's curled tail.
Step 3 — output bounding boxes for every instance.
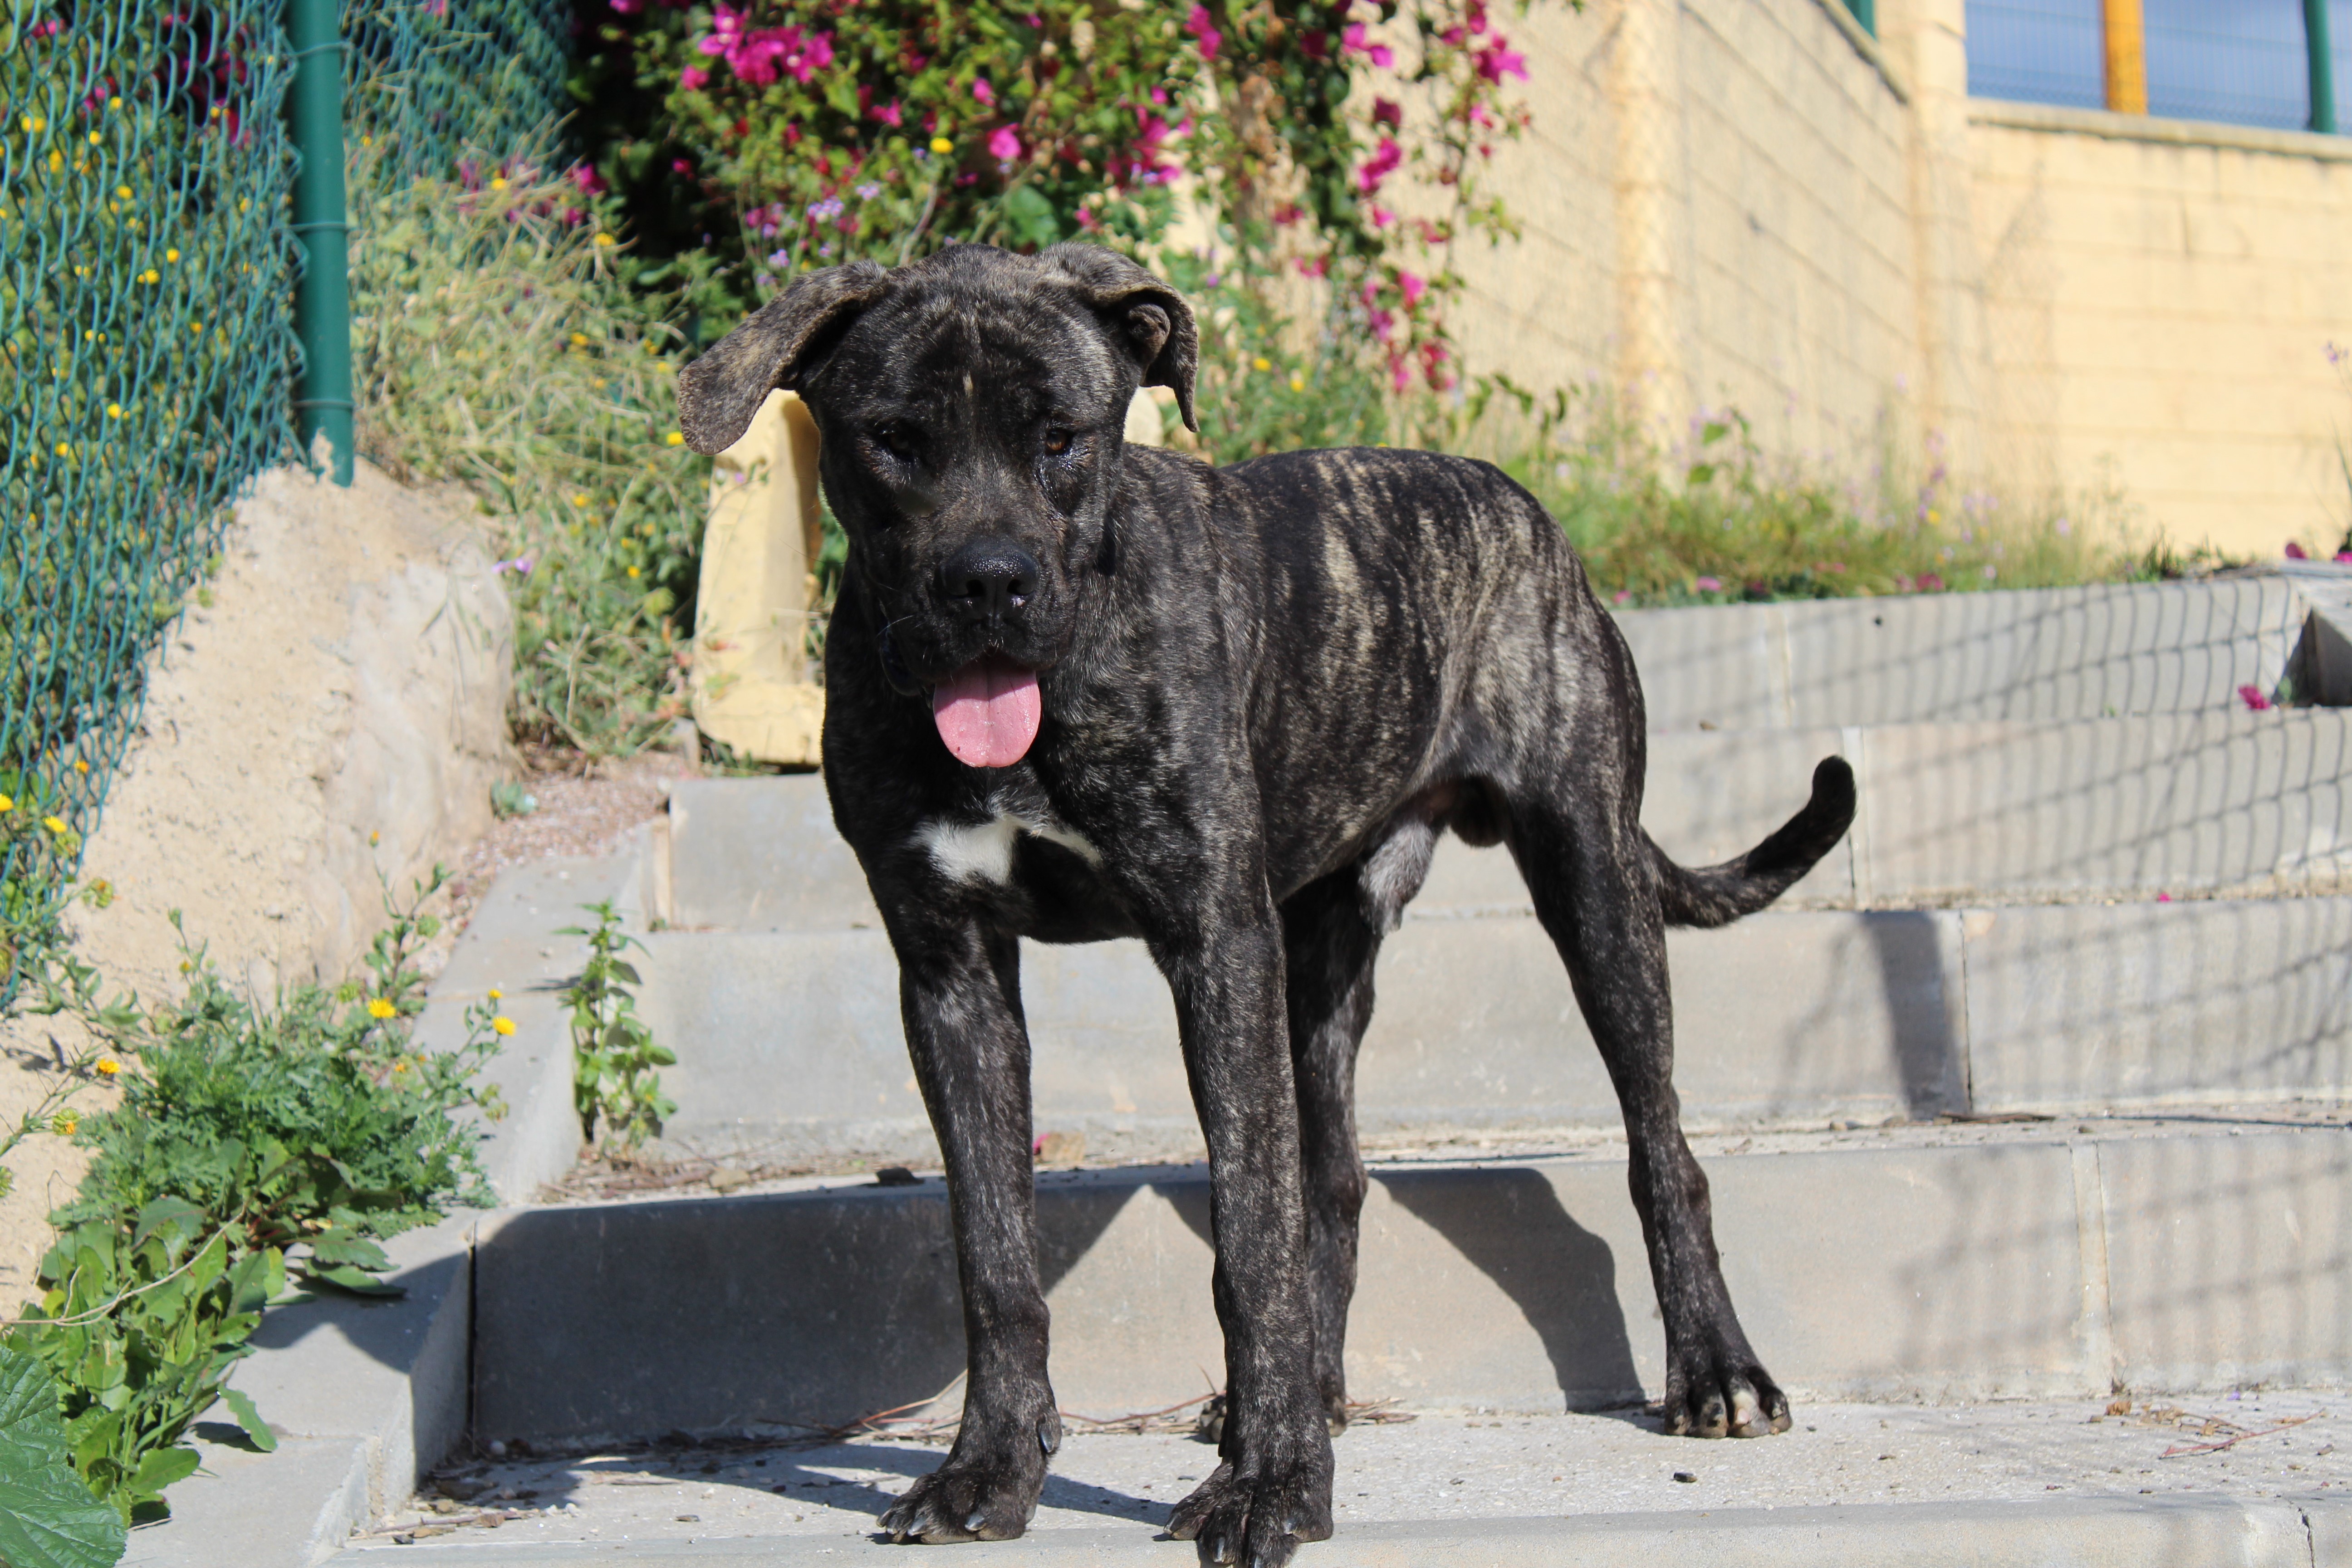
[670,708,2352,931]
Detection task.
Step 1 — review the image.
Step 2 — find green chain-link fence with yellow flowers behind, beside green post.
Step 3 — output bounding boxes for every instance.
[0,0,569,1001]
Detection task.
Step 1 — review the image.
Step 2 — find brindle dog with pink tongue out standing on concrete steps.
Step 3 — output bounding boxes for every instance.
[680,245,1853,1568]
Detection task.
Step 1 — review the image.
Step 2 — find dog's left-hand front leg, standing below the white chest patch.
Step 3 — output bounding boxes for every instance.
[882,917,1061,1542]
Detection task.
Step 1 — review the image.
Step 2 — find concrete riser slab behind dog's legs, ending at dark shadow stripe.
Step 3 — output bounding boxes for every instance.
[642,912,1969,1159]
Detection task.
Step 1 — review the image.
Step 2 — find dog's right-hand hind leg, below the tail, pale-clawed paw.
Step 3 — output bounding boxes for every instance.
[1510,789,1790,1436]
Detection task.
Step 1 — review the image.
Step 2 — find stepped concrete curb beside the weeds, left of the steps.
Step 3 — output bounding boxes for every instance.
[125,837,647,1568]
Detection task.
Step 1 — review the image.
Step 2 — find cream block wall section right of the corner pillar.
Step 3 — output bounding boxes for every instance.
[1969,101,2352,555]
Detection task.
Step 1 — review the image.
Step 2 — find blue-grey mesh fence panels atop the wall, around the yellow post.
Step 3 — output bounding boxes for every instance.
[1969,0,2352,129]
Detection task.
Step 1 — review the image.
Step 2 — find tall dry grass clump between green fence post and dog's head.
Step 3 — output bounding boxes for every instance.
[350,155,710,755]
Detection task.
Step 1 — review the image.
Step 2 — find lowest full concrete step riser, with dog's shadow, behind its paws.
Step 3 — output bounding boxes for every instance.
[473,1117,2352,1439]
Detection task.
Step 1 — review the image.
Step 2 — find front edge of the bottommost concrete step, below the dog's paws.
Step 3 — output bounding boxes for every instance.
[350,1495,2352,1568]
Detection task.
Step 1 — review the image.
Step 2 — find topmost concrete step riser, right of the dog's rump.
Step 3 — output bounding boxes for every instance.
[1618,569,2314,731]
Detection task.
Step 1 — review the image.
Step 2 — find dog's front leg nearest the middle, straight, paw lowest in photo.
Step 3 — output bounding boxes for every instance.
[1152,879,1331,1568]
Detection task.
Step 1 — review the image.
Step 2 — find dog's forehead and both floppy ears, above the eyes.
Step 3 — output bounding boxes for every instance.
[677,245,1200,451]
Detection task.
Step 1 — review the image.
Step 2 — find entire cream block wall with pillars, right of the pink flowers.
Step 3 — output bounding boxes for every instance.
[1456,0,2352,555]
